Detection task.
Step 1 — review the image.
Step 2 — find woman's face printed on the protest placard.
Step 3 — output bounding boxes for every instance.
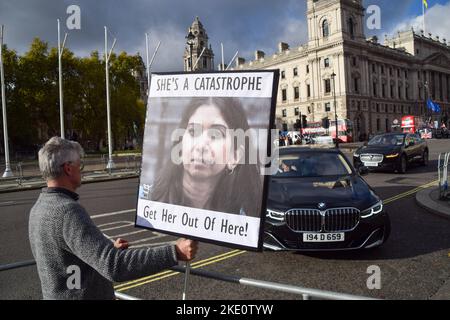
[182,104,233,179]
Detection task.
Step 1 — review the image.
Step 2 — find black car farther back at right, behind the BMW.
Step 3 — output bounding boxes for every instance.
[353,133,429,173]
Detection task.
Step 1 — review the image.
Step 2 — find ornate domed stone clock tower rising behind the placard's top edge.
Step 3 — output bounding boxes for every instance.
[183,17,214,71]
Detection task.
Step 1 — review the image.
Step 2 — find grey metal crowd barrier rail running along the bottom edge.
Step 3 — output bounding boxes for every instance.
[0,260,378,300]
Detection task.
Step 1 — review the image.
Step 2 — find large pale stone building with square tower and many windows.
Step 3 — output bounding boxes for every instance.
[234,0,450,139]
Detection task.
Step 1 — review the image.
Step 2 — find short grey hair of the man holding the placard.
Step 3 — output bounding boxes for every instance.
[38,137,84,180]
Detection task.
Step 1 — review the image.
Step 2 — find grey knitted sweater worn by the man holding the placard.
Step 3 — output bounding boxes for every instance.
[29,188,177,299]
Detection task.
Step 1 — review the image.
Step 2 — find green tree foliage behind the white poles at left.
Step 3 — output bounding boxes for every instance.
[0,38,145,151]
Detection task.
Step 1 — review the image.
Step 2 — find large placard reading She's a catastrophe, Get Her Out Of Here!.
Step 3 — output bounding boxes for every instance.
[136,70,278,250]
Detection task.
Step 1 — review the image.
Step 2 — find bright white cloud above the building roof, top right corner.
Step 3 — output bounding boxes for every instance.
[390,2,450,40]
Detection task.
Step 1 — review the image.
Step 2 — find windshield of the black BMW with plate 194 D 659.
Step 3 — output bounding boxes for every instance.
[274,152,352,178]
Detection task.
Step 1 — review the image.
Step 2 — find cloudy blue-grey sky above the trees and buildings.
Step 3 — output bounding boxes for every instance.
[0,0,450,71]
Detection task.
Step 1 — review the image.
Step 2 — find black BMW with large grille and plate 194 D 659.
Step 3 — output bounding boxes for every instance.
[264,147,391,251]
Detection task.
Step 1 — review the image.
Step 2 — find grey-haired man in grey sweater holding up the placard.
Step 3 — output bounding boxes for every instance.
[29,137,198,300]
